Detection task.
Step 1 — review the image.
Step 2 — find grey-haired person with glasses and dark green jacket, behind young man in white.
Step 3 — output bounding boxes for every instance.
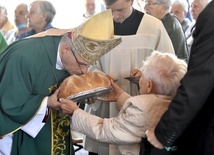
[144,0,189,60]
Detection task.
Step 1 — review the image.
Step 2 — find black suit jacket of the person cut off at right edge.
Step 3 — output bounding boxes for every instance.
[155,1,214,155]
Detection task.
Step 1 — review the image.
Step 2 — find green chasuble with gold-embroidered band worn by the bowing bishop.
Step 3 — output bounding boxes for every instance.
[0,36,73,155]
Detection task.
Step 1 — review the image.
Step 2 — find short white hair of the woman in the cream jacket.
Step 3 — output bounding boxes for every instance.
[142,51,187,96]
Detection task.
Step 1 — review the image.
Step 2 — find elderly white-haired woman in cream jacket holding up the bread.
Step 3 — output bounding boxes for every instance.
[60,51,187,155]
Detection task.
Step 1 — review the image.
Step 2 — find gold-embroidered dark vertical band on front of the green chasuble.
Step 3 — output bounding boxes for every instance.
[52,110,71,155]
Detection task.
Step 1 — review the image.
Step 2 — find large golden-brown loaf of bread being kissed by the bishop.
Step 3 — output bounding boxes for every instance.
[59,72,111,98]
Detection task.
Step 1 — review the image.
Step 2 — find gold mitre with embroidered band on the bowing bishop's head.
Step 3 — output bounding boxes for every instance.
[71,9,121,63]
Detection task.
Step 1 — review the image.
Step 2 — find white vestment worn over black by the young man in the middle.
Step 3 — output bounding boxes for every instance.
[84,14,174,155]
